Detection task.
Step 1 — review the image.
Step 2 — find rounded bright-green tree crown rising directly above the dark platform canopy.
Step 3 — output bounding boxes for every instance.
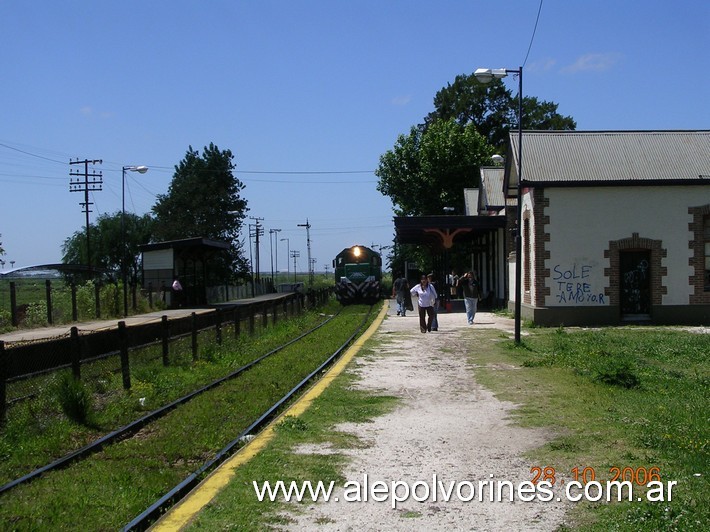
[375,118,493,216]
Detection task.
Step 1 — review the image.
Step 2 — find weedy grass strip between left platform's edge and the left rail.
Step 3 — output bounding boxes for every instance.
[0,305,337,483]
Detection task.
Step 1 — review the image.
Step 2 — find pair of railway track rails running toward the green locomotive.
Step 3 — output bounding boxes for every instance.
[0,302,378,530]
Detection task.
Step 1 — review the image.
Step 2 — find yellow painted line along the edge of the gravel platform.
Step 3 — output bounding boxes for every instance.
[151,301,389,531]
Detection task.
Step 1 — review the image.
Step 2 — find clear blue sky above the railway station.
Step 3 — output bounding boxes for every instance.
[0,0,710,271]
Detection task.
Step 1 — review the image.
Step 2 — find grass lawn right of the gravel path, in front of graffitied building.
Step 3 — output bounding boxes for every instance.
[471,328,710,530]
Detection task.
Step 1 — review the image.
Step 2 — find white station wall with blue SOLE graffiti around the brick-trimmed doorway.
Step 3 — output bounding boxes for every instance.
[544,186,710,306]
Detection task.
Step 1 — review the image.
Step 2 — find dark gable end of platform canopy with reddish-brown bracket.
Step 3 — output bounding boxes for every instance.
[394,215,506,249]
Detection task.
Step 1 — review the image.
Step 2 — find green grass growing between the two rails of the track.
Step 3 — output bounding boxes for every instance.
[0,307,376,530]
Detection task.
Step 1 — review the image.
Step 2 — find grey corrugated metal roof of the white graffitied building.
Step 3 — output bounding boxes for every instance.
[508,131,710,188]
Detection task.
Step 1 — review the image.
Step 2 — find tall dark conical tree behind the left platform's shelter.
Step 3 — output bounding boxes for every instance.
[153,143,248,275]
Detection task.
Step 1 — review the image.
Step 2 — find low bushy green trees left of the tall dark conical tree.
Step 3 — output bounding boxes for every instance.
[62,211,154,284]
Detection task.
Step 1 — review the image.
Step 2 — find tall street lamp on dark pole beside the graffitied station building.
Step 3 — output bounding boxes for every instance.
[473,67,523,344]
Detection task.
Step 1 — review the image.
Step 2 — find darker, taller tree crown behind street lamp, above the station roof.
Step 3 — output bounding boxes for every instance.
[425,74,577,153]
